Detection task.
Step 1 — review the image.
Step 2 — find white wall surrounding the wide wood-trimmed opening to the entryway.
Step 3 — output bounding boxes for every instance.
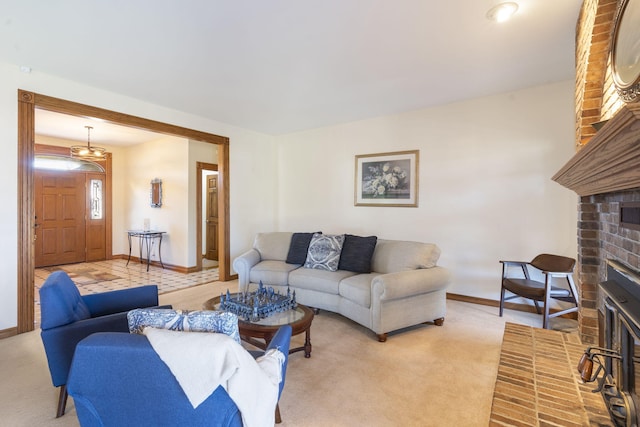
[0,62,276,331]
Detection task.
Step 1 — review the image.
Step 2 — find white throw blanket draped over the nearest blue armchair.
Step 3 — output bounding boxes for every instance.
[143,328,284,427]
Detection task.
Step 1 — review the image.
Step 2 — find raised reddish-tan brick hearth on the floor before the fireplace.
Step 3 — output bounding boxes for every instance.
[489,323,613,427]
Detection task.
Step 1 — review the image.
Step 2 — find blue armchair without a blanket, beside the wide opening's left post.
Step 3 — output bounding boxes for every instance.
[40,271,165,417]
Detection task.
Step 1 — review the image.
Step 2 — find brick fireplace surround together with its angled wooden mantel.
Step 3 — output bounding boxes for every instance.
[553,103,640,344]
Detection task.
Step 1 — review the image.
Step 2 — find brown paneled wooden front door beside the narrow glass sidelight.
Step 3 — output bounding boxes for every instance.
[34,171,85,267]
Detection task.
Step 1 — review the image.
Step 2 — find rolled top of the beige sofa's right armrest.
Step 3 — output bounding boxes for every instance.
[371,267,451,300]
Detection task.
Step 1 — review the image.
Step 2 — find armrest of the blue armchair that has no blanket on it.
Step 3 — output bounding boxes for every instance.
[82,285,158,317]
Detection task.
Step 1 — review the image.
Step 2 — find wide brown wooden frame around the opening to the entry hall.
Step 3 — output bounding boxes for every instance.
[17,89,231,333]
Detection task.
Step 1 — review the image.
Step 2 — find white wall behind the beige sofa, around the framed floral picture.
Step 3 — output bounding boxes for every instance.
[277,81,577,300]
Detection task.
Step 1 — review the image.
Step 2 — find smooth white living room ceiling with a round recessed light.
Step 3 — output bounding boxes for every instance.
[0,0,582,141]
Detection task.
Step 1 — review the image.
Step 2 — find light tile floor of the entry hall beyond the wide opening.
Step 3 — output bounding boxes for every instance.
[34,259,219,325]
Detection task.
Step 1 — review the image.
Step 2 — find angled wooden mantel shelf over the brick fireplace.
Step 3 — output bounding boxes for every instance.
[551,103,640,196]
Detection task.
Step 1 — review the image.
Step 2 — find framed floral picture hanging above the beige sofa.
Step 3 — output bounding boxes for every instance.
[355,150,420,208]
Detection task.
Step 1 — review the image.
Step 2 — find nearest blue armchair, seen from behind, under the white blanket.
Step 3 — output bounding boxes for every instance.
[67,326,291,427]
